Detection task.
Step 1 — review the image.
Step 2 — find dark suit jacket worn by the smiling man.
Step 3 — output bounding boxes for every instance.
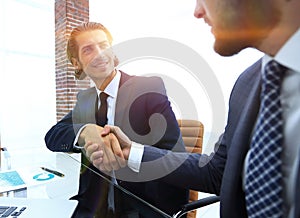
[45,72,188,214]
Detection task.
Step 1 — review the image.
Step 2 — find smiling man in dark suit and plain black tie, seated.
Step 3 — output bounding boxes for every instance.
[45,22,188,218]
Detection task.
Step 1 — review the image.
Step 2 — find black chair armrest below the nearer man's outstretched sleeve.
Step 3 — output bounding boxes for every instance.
[173,196,220,218]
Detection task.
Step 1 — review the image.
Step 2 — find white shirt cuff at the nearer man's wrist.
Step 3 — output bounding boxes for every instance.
[128,142,144,173]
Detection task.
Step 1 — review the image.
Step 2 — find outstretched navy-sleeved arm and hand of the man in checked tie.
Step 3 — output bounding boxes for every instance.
[86,126,227,194]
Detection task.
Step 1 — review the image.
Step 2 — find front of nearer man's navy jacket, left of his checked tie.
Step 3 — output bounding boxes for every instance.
[220,58,261,217]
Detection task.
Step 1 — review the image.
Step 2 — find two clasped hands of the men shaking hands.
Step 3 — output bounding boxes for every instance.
[80,124,132,172]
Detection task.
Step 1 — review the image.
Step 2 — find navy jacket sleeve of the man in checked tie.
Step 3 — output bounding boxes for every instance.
[139,136,227,195]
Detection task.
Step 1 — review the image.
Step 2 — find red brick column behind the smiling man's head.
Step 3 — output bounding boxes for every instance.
[55,0,90,120]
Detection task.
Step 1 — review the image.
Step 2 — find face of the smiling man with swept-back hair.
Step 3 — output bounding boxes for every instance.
[73,30,114,83]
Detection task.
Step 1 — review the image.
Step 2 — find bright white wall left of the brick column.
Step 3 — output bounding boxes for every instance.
[0,0,56,150]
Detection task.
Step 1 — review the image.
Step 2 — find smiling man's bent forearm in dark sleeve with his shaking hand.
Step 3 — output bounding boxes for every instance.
[45,112,125,171]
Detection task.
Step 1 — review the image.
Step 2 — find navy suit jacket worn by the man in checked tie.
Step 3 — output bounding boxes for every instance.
[141,60,300,218]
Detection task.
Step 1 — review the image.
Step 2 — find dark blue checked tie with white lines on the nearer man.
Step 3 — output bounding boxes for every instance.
[245,61,286,218]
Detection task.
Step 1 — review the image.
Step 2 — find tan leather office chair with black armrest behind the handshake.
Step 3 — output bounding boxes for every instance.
[173,119,220,218]
